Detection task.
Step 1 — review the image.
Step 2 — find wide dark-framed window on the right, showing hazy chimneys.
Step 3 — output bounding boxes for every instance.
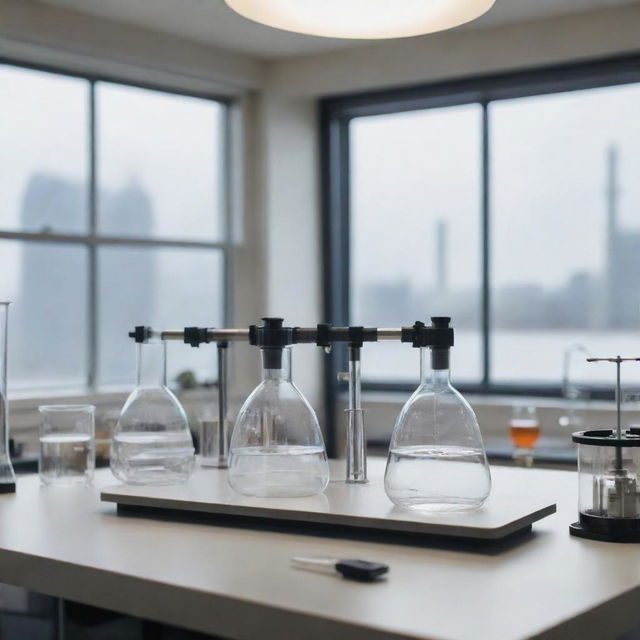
[323,59,640,395]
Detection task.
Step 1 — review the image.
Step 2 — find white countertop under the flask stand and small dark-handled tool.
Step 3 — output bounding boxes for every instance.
[0,460,640,640]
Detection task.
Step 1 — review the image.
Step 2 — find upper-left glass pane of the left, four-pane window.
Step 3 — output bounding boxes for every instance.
[0,64,89,233]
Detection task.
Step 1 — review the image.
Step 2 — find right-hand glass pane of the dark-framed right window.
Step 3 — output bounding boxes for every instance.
[489,85,640,384]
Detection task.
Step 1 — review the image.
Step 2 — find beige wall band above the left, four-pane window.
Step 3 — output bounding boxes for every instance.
[0,0,263,95]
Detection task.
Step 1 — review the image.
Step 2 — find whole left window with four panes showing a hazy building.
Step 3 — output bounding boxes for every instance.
[0,64,228,393]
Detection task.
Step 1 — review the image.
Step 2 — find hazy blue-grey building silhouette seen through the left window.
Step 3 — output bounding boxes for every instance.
[11,174,155,386]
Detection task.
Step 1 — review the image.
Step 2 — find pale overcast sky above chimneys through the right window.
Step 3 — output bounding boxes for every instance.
[352,80,640,289]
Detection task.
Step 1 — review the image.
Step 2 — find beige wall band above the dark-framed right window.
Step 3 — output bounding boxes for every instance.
[267,0,640,97]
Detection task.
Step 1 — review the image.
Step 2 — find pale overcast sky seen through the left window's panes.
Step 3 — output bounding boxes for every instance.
[0,65,223,298]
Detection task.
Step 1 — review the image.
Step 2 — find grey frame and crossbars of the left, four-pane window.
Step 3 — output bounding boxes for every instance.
[0,56,236,398]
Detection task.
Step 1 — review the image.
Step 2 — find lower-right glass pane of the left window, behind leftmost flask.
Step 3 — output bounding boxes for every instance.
[98,247,224,386]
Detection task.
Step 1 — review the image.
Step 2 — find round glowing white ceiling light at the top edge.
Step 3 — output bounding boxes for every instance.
[225,0,495,39]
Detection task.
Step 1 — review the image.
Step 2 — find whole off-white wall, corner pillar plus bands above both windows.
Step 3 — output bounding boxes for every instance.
[0,0,640,440]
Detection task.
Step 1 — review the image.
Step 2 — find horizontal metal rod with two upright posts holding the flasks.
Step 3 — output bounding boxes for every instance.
[129,318,452,484]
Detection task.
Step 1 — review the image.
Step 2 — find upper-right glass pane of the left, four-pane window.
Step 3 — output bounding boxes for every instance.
[96,83,224,241]
